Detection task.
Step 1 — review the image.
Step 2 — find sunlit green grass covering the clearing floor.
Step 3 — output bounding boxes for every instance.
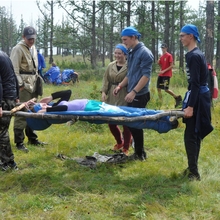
[0,71,220,220]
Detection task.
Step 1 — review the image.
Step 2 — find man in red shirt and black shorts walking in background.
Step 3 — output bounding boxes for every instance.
[157,43,182,108]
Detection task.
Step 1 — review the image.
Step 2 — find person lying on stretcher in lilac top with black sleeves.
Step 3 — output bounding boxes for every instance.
[26,90,128,113]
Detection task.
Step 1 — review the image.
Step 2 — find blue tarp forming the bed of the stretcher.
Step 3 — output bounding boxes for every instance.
[26,106,178,133]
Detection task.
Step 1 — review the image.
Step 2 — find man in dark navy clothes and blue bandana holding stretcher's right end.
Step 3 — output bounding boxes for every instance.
[179,24,213,180]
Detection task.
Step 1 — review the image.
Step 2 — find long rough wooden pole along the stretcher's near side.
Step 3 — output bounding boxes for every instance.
[2,110,184,122]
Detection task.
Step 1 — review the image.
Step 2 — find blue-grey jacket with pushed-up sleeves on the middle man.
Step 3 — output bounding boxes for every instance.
[127,42,154,96]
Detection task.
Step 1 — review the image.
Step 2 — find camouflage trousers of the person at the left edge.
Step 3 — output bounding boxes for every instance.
[0,100,15,163]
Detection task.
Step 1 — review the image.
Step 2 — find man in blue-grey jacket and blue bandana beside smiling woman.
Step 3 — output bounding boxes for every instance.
[113,27,154,160]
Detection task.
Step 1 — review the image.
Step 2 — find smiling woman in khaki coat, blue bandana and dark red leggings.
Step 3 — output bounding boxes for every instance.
[101,44,131,155]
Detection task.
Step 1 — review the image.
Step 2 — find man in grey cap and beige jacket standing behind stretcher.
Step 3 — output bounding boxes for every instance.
[10,26,43,152]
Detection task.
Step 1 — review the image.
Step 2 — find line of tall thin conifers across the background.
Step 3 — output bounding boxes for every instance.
[0,0,220,70]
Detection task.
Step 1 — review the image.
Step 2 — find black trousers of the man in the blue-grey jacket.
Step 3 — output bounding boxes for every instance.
[128,92,150,156]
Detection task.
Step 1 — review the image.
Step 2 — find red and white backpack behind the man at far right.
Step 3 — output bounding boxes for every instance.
[207,63,218,99]
